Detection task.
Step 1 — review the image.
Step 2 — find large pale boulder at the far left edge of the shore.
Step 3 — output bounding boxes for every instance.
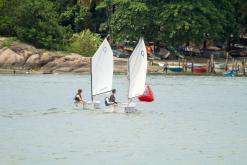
[0,49,25,68]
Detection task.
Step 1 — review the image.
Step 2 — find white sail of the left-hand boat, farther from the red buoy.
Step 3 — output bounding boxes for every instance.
[91,39,113,96]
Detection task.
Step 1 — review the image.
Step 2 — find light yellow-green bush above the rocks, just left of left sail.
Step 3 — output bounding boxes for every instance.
[66,30,102,56]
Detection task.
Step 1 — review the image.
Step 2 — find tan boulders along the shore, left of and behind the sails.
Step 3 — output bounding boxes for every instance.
[0,42,162,74]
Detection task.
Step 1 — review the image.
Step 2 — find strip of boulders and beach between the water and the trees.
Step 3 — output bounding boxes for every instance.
[0,37,246,76]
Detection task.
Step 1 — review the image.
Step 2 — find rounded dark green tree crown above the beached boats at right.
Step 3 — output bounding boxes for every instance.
[158,0,223,44]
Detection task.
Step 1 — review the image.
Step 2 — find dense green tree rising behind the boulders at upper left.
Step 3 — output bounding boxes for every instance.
[16,0,71,49]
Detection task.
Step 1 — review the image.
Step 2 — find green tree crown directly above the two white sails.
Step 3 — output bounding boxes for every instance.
[98,0,149,41]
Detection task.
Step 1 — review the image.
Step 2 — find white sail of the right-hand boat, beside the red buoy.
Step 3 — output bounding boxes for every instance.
[128,38,147,98]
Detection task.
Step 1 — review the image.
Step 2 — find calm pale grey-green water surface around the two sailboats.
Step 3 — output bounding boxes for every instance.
[0,74,247,165]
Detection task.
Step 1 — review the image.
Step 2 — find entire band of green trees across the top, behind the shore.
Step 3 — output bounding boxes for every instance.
[0,0,247,50]
